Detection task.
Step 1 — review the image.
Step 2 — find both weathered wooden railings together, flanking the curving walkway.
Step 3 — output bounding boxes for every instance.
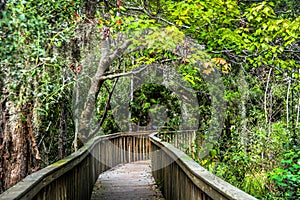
[0,132,255,200]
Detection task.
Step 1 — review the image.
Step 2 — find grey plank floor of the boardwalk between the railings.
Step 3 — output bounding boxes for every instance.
[91,160,164,200]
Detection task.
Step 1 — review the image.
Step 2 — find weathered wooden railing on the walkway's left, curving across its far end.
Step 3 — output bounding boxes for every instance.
[0,133,150,200]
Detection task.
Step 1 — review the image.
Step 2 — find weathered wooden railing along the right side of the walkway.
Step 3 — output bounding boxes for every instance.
[149,133,256,200]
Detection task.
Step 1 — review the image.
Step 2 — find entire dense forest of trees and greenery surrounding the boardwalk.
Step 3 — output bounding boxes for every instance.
[0,0,300,199]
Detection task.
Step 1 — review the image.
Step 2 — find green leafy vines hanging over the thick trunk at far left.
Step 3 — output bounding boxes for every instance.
[0,0,80,165]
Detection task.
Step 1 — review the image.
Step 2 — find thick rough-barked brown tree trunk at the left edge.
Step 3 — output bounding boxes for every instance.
[0,83,41,192]
